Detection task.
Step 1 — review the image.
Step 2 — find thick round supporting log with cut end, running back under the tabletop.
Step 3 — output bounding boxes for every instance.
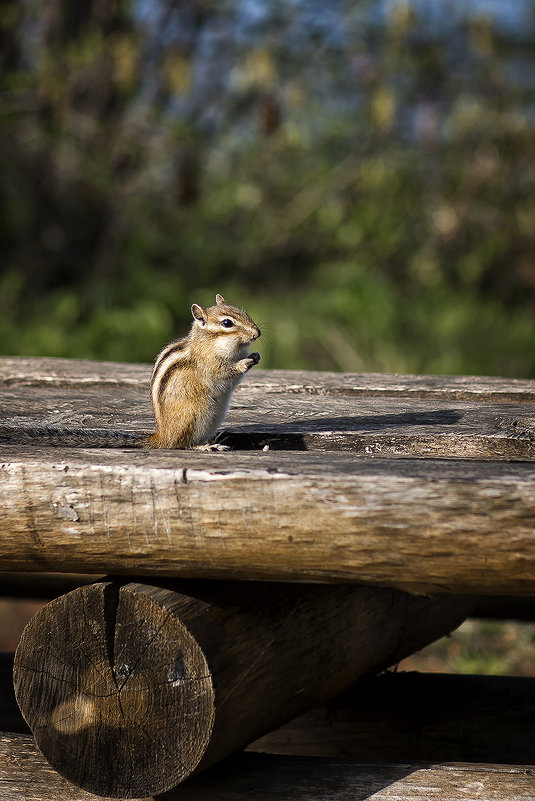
[14,581,473,797]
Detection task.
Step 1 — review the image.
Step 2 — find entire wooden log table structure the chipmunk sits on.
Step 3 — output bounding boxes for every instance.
[0,359,535,801]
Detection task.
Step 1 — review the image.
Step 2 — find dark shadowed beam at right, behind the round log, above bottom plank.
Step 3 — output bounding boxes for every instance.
[249,672,535,765]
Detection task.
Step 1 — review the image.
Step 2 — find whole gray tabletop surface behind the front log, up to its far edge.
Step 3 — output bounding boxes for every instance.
[0,359,535,459]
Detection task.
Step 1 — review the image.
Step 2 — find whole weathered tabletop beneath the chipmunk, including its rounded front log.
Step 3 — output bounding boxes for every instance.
[0,359,535,594]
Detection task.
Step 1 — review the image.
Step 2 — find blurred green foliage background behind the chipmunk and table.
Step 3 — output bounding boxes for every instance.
[0,0,535,376]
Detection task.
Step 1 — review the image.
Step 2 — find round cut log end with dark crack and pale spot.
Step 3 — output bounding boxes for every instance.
[14,583,214,797]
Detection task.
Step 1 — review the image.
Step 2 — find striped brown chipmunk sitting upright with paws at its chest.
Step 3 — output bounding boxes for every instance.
[148,295,261,450]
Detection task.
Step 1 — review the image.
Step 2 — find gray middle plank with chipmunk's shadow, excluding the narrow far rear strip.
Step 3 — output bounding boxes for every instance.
[0,376,535,460]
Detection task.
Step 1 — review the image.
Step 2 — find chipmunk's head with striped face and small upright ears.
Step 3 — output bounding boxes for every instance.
[191,295,261,358]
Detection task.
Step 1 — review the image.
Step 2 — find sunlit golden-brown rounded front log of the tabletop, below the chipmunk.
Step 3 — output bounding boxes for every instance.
[0,445,535,595]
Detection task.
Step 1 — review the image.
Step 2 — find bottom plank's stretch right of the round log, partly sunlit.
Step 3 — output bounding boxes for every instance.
[178,754,535,801]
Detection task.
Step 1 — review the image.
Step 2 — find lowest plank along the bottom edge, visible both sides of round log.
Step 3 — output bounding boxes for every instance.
[0,733,535,801]
